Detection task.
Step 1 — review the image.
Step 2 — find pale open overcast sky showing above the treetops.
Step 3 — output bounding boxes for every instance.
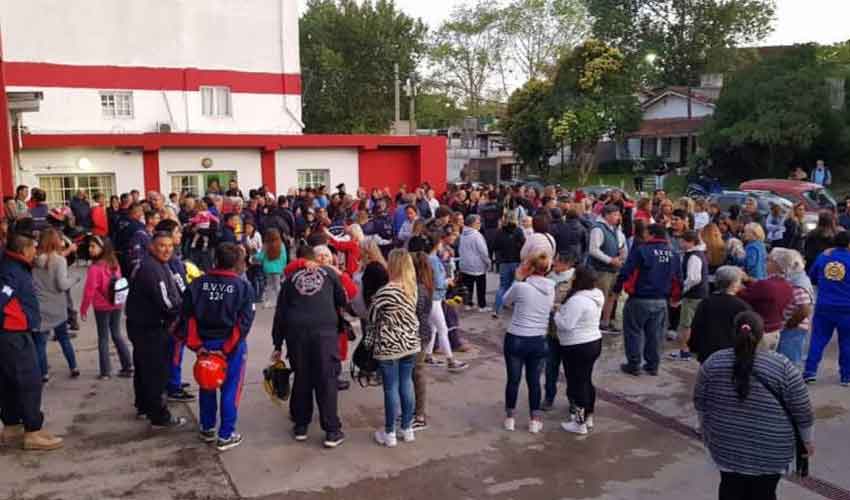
[298,0,850,45]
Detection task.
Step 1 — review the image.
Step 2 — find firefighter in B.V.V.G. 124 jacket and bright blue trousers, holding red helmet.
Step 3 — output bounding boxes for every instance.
[183,243,254,451]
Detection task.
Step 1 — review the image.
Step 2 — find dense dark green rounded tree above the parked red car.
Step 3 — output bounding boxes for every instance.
[702,45,848,177]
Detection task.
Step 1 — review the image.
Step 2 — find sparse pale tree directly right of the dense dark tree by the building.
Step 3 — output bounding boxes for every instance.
[429,0,505,116]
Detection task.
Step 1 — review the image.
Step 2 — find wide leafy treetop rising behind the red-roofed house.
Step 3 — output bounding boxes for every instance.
[584,0,776,85]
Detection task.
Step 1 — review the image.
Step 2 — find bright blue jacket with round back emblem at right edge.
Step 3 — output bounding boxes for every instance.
[809,248,850,313]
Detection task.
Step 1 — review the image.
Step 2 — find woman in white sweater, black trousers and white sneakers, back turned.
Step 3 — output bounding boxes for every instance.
[555,266,605,434]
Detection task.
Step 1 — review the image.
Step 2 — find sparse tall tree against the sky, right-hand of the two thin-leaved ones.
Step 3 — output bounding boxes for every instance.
[501,0,590,81]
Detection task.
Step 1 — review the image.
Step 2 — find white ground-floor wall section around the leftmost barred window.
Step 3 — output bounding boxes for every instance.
[15,149,145,194]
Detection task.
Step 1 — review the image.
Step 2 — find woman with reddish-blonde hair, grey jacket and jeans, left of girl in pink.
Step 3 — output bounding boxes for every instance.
[32,228,80,382]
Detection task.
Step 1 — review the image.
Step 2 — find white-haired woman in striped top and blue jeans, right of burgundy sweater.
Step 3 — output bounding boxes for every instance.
[769,248,815,369]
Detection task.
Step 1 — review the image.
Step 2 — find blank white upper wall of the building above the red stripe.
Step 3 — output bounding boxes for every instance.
[0,0,300,73]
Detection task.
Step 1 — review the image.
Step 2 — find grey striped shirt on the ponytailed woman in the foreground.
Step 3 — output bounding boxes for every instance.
[694,349,814,475]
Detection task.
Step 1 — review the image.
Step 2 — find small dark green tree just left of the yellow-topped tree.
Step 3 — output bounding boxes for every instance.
[502,80,557,175]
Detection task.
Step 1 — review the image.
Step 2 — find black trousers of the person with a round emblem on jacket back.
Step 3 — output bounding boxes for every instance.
[286,331,342,432]
